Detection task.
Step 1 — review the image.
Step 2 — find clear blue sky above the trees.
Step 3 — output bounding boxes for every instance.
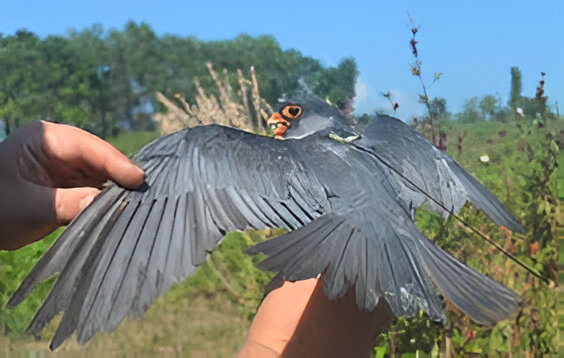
[0,0,564,119]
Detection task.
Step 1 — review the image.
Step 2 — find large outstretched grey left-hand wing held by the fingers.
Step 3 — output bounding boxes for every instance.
[8,125,330,349]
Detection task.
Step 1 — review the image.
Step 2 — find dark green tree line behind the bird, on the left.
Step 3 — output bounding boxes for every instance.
[0,22,358,137]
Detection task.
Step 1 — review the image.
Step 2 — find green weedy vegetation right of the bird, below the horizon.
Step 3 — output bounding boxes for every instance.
[366,119,564,356]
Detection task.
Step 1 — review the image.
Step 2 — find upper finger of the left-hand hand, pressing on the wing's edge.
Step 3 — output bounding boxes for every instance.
[44,122,145,188]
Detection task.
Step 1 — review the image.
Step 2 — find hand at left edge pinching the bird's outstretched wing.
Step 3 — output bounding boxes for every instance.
[0,121,145,250]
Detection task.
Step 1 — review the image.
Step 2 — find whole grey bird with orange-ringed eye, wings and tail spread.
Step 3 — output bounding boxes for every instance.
[8,95,525,349]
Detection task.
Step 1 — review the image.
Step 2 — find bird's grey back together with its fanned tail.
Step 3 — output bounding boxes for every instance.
[247,144,519,325]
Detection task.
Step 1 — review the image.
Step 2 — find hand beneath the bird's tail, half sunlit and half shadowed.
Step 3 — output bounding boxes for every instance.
[238,279,393,358]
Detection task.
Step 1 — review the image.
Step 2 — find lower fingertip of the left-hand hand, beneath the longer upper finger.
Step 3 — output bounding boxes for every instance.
[55,188,100,225]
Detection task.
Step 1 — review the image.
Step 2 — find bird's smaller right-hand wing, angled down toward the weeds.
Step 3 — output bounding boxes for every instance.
[355,115,525,233]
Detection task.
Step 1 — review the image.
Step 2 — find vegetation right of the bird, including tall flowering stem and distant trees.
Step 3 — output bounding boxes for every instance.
[370,21,562,356]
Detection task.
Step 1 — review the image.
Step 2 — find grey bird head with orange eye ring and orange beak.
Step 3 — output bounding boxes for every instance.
[266,96,352,139]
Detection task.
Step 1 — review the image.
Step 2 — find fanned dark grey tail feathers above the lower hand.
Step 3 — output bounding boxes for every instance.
[247,214,519,326]
